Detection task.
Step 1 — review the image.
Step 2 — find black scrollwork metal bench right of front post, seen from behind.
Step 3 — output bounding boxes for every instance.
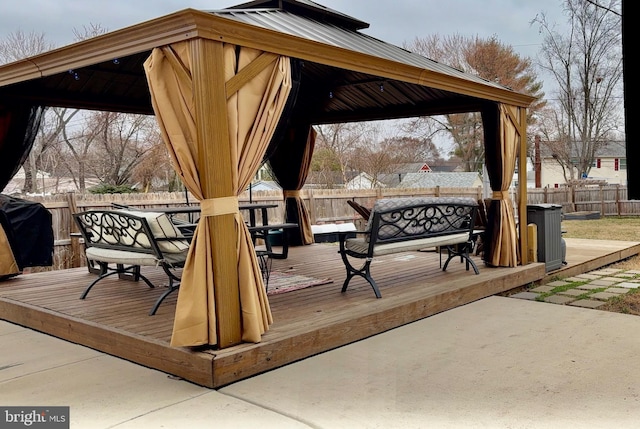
[339,197,479,298]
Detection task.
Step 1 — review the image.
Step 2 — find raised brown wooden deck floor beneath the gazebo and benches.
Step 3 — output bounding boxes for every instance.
[0,240,640,388]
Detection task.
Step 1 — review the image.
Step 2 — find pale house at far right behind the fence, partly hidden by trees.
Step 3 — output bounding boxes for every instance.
[540,141,627,188]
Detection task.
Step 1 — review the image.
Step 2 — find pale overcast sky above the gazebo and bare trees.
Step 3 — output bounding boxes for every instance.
[0,0,564,58]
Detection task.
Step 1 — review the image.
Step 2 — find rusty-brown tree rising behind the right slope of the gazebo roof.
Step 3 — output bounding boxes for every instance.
[407,35,545,172]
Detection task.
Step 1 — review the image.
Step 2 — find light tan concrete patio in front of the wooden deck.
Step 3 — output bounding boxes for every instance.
[0,297,640,429]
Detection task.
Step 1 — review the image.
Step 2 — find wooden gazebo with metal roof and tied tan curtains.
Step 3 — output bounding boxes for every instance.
[0,0,533,348]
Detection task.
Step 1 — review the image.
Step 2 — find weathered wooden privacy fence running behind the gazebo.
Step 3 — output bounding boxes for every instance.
[17,182,640,269]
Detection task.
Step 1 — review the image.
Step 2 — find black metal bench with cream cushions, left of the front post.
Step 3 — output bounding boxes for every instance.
[74,210,189,315]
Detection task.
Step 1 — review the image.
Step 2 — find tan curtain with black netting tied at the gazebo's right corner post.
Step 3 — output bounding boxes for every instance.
[482,104,520,267]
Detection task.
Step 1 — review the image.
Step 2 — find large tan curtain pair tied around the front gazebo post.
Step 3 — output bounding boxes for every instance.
[145,41,291,346]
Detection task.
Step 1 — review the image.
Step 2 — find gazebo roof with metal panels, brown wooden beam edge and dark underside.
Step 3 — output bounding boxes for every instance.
[0,0,533,123]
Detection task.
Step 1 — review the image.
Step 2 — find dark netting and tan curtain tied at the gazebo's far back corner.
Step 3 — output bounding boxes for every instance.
[268,125,316,245]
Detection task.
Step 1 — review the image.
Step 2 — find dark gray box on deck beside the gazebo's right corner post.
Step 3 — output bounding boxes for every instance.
[527,204,564,273]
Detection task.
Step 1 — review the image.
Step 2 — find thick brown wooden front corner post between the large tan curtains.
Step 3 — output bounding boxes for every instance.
[191,39,242,348]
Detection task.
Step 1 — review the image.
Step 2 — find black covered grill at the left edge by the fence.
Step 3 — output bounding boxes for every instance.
[0,194,53,270]
